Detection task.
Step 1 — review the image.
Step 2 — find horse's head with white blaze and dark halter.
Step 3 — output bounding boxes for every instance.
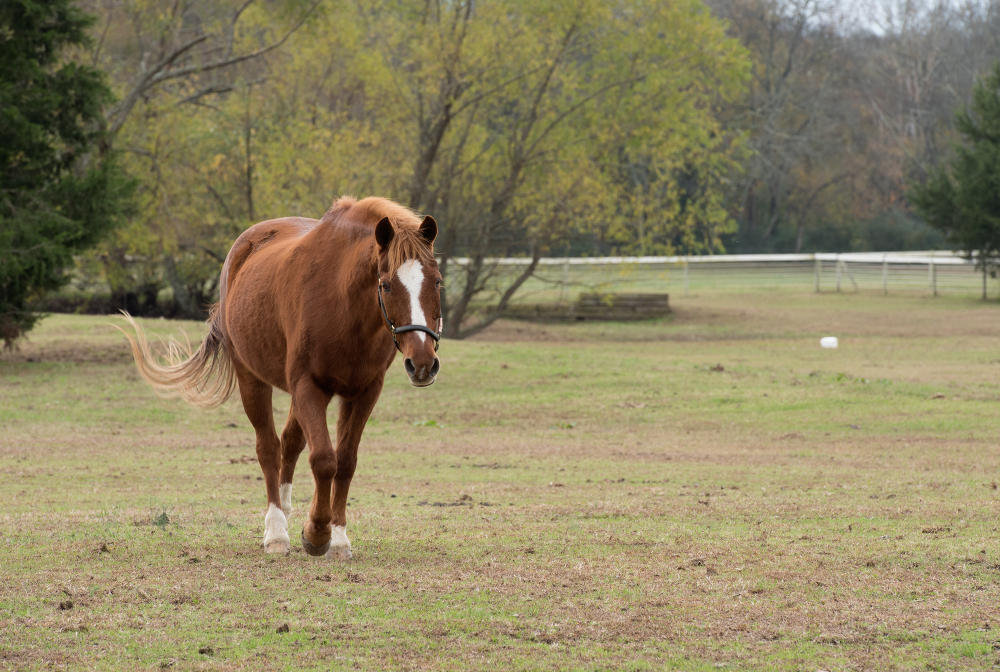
[375,216,442,387]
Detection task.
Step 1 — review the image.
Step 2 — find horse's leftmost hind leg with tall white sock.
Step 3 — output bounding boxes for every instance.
[233,361,291,553]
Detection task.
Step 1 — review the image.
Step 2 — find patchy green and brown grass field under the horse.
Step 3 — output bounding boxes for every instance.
[0,293,1000,671]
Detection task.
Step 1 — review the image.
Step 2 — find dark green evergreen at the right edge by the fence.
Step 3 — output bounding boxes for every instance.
[910,61,1000,299]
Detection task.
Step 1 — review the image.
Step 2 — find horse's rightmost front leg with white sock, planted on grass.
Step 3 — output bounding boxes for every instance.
[326,380,382,560]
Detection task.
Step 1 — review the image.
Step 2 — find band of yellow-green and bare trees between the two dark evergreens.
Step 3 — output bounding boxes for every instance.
[54,0,1000,333]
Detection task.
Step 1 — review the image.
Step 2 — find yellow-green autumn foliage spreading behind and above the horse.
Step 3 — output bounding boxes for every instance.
[84,0,746,327]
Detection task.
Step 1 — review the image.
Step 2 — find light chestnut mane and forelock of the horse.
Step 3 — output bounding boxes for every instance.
[326,196,434,273]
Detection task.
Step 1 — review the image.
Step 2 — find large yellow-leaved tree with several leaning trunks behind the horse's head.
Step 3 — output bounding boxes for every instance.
[367,0,746,337]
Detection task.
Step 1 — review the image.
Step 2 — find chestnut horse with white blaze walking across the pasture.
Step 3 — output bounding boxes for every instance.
[120,197,441,559]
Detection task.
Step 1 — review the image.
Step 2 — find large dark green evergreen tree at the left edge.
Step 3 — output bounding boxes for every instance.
[0,0,131,347]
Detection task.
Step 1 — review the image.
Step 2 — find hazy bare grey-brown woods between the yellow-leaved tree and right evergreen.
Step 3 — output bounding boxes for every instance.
[709,0,1000,252]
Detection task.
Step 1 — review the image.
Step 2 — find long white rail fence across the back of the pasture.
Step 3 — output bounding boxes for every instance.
[449,251,1000,303]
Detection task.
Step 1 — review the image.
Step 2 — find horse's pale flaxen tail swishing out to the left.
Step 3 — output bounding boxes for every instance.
[115,304,236,408]
